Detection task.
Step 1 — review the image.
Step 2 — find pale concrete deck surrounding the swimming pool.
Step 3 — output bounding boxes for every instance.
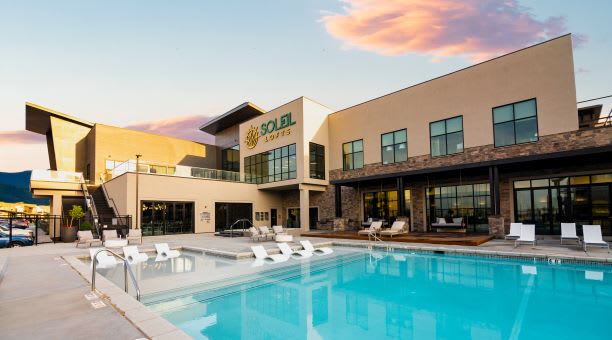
[0,234,612,339]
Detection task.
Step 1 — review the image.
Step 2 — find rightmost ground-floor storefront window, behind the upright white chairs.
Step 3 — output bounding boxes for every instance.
[513,174,612,235]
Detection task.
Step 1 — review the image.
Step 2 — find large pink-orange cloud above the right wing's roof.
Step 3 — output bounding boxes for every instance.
[322,0,585,61]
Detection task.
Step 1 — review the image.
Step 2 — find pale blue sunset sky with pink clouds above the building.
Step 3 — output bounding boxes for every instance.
[0,0,612,172]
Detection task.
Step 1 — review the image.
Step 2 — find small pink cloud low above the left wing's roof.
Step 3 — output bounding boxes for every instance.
[126,115,215,144]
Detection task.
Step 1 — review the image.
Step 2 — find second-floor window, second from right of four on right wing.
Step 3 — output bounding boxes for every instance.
[429,116,463,157]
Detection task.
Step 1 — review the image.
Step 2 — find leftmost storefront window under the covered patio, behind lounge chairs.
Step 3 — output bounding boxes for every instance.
[363,190,411,223]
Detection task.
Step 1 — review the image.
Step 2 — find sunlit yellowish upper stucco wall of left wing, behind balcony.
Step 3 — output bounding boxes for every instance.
[89,124,217,181]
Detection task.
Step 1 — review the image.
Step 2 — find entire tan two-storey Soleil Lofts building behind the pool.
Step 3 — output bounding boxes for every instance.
[26,35,612,236]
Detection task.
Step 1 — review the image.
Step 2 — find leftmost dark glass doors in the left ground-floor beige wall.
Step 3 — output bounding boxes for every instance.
[141,201,194,236]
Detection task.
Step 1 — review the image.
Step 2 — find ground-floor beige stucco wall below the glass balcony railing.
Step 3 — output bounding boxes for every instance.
[105,173,282,233]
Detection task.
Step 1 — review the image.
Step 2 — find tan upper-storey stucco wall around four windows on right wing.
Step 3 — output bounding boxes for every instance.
[329,36,578,169]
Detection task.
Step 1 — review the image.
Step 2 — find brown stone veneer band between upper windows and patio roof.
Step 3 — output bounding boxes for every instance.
[329,127,612,181]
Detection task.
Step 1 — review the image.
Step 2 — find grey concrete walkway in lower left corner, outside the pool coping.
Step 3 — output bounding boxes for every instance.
[0,254,143,340]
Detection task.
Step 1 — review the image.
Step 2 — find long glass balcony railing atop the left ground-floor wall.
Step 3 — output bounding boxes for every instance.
[107,160,240,182]
